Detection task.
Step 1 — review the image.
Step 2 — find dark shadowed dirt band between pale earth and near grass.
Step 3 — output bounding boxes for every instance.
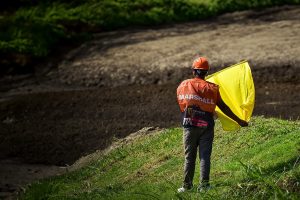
[0,79,300,165]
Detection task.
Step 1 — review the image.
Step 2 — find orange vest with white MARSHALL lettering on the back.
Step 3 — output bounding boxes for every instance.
[177,78,220,113]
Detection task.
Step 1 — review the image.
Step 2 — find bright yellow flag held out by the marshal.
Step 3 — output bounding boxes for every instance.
[206,61,255,131]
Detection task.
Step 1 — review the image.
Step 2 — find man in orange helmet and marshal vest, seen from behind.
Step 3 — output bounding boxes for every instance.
[177,57,248,192]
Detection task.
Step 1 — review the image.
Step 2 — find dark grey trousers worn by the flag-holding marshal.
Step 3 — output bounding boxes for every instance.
[183,127,214,188]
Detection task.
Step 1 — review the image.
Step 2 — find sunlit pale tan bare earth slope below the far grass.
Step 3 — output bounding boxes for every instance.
[59,7,300,86]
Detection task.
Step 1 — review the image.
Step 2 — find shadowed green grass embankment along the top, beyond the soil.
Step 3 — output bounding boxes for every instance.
[0,0,300,72]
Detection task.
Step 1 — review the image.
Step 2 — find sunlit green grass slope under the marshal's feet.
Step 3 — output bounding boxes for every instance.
[21,117,300,199]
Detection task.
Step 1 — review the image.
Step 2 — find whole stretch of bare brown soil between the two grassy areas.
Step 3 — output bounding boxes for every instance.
[0,6,300,198]
